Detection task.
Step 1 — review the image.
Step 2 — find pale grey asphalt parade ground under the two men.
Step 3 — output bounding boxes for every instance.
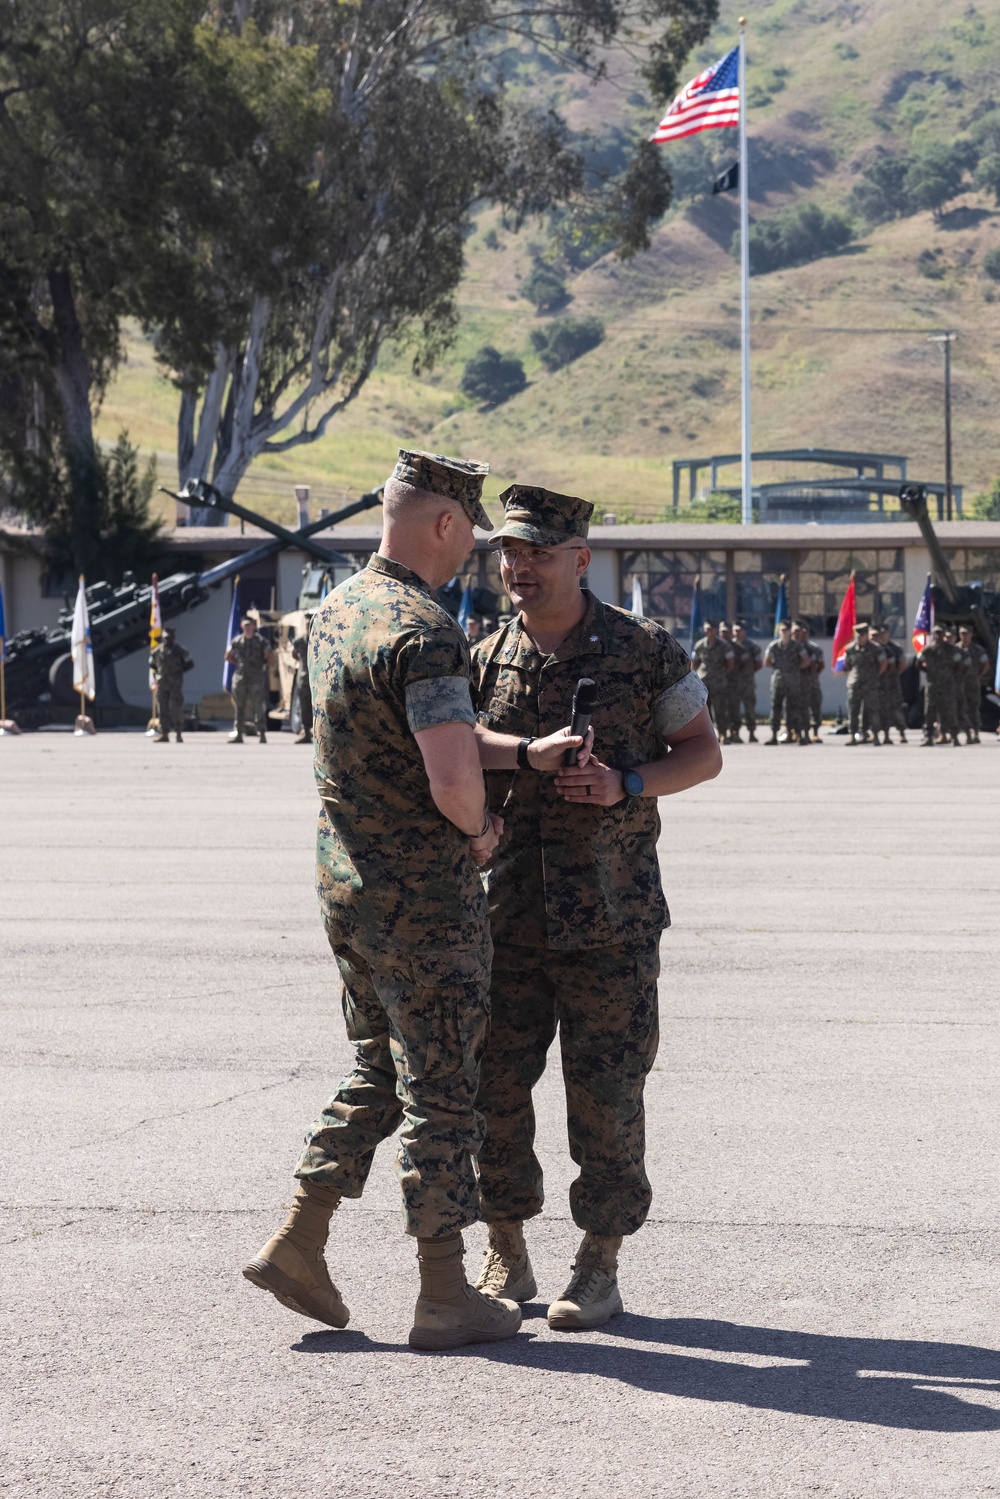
[0,732,1000,1499]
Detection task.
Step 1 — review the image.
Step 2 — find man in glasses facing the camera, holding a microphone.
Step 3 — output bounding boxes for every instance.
[472,484,723,1328]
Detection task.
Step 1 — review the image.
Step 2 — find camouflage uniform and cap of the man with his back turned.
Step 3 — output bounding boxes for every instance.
[295,454,490,1238]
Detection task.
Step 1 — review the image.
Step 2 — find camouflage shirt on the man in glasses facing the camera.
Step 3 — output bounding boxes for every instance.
[472,592,706,950]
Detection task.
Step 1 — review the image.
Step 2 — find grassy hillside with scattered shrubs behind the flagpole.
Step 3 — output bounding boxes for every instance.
[100,0,1000,519]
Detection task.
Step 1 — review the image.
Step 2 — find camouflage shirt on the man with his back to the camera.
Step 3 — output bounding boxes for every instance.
[309,555,487,952]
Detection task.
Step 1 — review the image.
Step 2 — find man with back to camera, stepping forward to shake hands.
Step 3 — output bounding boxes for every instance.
[243,451,580,1349]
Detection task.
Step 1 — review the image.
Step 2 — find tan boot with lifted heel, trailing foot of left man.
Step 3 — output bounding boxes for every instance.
[243,1181,351,1327]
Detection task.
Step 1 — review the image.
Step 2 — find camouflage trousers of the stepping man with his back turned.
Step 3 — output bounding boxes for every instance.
[295,937,490,1238]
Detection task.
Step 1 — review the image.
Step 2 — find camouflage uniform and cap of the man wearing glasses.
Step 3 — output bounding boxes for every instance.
[472,499,706,1237]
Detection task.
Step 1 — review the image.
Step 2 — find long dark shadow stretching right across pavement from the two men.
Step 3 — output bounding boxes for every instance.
[476,1315,1000,1432]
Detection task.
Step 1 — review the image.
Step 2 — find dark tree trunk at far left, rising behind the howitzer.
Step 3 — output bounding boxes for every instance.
[48,268,100,583]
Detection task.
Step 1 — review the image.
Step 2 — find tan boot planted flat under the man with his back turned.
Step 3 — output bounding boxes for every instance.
[409,1234,520,1349]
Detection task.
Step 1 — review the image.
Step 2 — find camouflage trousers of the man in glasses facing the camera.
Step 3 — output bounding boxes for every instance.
[478,940,660,1237]
